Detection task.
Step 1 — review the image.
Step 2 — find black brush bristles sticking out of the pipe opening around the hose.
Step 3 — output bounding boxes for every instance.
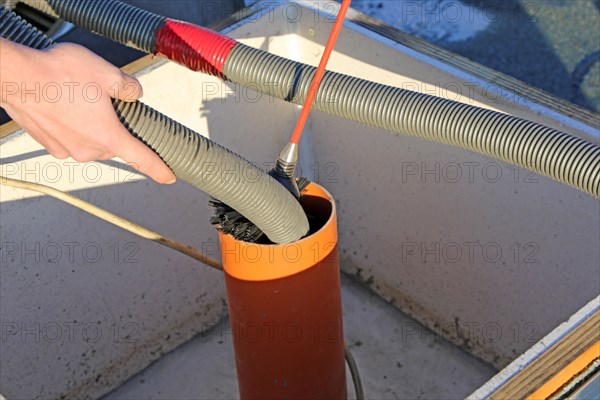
[208,177,310,243]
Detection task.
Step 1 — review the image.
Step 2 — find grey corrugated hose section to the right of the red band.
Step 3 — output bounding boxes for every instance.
[223,43,600,197]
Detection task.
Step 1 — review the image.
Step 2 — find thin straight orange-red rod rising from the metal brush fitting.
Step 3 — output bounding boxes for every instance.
[290,0,351,144]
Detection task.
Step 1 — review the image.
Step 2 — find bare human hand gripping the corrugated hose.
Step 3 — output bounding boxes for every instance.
[0,39,175,183]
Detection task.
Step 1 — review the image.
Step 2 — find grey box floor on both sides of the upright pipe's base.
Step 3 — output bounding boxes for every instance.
[103,276,495,400]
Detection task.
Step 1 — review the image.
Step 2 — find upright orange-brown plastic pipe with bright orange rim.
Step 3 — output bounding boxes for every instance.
[219,183,347,399]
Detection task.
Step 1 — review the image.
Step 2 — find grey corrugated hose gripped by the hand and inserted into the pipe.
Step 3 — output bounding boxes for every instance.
[0,6,309,244]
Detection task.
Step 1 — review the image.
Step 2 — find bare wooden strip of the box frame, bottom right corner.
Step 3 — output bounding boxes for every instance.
[489,311,600,399]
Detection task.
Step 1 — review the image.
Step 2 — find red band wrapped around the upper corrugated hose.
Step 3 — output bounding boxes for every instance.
[156,20,237,79]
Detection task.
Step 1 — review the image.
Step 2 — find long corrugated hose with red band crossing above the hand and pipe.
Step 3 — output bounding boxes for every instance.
[28,0,600,198]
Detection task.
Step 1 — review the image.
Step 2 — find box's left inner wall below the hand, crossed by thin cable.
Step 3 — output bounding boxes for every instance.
[0,134,225,400]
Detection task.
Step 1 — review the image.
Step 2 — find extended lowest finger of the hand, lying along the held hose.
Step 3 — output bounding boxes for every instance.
[115,128,176,184]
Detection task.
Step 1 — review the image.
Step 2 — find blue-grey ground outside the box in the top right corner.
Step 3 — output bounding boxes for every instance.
[346,0,600,112]
